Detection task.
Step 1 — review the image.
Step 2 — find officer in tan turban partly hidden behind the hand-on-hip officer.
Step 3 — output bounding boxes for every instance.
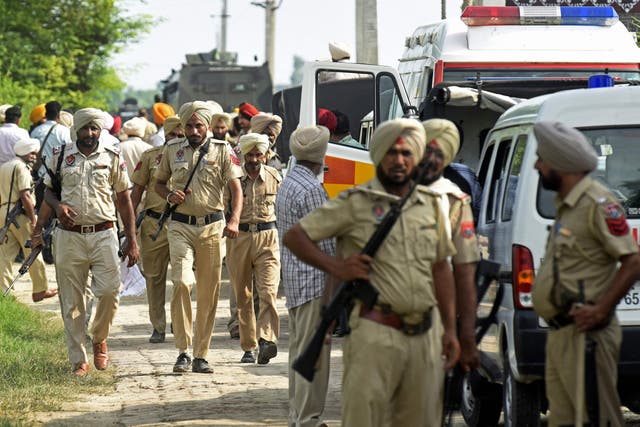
[422,119,480,372]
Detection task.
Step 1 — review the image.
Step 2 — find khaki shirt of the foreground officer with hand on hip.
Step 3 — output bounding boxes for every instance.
[300,178,455,314]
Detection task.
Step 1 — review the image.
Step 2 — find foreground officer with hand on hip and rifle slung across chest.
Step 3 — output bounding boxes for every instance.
[283,119,460,426]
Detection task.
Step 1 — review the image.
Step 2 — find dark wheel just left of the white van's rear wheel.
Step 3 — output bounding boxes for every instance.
[460,371,502,427]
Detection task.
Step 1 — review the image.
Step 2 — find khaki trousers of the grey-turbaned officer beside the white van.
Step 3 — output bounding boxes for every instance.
[545,318,624,427]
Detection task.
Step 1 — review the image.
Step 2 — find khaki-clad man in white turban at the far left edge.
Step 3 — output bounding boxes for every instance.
[0,138,58,302]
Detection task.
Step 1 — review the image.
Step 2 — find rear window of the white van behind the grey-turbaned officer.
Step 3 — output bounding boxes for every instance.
[537,127,640,218]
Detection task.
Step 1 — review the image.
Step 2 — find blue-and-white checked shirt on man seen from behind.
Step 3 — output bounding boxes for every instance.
[276,164,336,309]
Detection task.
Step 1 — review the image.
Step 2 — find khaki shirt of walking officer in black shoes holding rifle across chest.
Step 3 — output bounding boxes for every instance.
[156,138,242,216]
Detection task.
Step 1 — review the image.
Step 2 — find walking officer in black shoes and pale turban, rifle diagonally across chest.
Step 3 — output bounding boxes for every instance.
[155,101,242,373]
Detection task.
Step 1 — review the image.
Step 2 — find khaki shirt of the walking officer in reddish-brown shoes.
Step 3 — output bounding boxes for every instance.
[44,141,131,225]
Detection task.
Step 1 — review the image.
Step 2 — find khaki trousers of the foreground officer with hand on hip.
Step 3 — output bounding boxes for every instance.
[342,304,442,427]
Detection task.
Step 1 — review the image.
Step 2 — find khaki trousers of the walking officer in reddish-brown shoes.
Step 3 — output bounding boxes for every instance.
[53,227,120,364]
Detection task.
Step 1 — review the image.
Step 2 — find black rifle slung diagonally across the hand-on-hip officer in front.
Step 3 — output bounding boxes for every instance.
[293,162,431,382]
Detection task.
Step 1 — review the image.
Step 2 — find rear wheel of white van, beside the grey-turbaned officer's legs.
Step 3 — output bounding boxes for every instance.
[502,350,542,427]
